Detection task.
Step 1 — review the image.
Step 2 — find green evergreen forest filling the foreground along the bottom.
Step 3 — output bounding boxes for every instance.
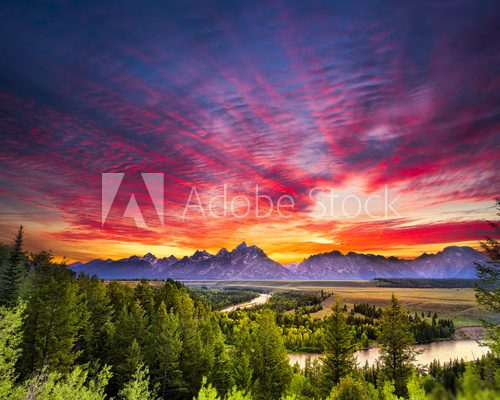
[0,225,500,400]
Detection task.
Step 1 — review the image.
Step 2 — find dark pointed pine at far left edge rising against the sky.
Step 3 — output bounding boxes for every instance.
[0,226,27,306]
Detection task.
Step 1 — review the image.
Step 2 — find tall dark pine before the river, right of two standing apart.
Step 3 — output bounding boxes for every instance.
[378,294,417,397]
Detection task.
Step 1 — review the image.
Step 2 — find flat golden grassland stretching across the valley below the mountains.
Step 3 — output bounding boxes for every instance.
[109,280,500,327]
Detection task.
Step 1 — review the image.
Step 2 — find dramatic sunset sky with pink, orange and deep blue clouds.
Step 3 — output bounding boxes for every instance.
[0,0,500,263]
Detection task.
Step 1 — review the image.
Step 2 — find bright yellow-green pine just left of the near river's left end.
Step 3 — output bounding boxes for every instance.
[252,309,292,400]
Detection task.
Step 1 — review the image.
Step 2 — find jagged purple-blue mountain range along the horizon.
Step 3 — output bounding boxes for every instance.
[70,242,487,280]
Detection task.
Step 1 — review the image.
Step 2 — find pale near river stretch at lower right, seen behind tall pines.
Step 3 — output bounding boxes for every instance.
[288,340,488,368]
